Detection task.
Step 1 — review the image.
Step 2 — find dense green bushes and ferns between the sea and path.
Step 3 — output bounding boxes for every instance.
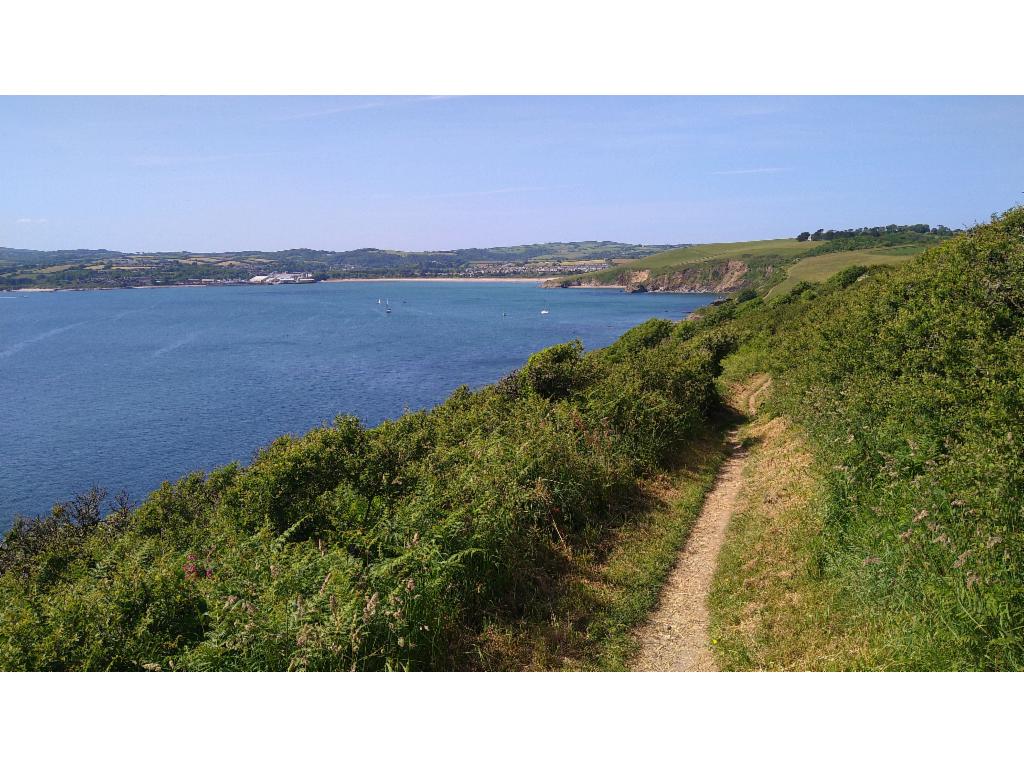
[0,321,728,670]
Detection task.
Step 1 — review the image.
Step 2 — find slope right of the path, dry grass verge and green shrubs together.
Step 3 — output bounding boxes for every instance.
[706,209,1024,670]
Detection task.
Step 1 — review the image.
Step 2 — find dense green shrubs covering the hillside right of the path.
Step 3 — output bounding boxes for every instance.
[729,209,1024,670]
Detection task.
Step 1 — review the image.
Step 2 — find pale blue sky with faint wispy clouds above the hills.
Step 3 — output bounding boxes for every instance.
[0,96,1024,252]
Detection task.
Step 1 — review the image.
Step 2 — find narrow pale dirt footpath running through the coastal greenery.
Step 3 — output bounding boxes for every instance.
[634,376,771,672]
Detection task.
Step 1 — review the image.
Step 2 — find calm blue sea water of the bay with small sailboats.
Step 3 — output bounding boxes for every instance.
[0,283,716,531]
